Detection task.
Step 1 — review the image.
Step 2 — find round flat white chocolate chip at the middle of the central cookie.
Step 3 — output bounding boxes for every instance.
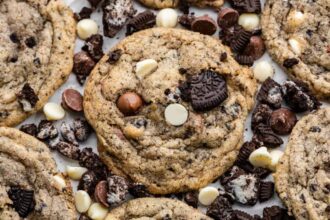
[165,104,188,126]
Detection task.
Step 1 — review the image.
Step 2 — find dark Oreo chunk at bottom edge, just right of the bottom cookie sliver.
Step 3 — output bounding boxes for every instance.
[206,196,235,220]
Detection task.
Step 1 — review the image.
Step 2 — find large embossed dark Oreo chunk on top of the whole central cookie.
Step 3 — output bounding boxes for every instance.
[179,70,228,111]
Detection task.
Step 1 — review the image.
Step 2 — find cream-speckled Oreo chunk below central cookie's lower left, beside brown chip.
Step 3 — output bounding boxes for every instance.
[107,175,128,207]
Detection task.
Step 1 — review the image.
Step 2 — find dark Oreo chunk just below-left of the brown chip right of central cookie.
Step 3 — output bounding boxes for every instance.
[254,124,283,147]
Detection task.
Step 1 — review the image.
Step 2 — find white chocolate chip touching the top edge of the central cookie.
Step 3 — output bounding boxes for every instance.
[156,8,178,28]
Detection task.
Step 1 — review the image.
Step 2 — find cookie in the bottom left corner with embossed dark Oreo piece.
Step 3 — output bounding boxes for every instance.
[0,127,77,220]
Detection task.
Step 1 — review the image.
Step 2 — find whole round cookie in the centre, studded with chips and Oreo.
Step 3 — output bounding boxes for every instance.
[84,28,257,194]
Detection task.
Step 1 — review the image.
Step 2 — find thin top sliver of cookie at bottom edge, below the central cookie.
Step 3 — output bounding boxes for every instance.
[105,198,211,220]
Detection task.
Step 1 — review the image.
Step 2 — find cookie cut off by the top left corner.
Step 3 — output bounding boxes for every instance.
[0,0,75,126]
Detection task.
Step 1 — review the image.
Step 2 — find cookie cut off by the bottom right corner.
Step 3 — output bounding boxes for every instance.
[274,108,330,220]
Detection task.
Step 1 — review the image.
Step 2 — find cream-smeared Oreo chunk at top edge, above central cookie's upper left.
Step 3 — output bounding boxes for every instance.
[102,0,136,37]
